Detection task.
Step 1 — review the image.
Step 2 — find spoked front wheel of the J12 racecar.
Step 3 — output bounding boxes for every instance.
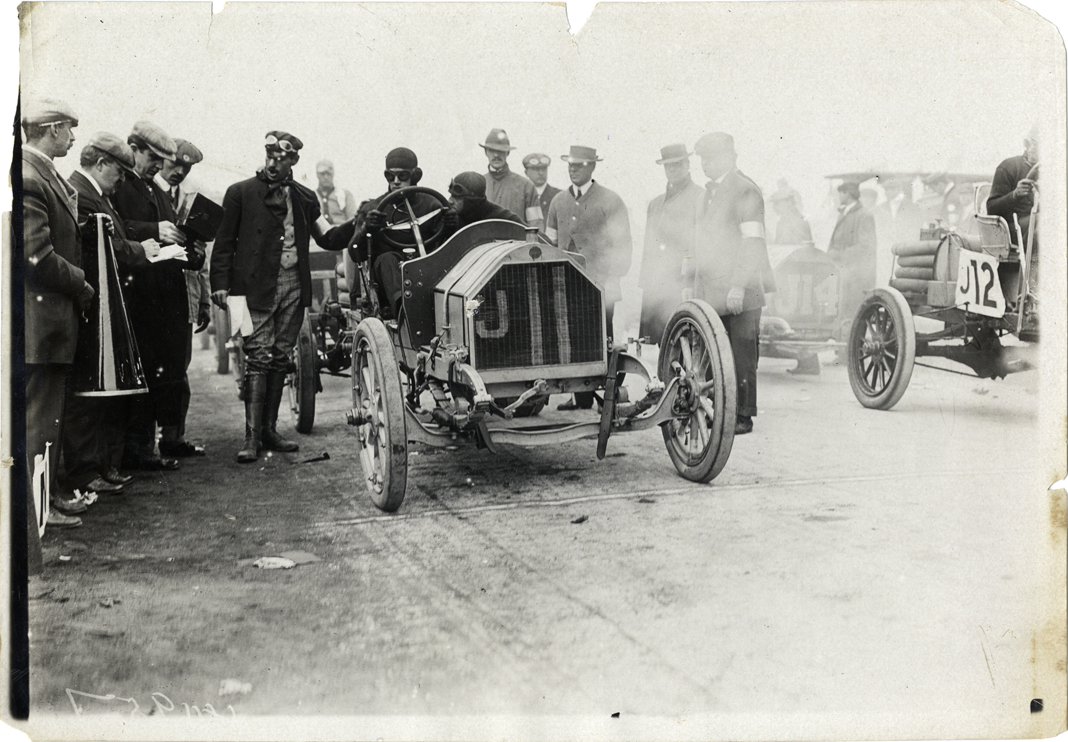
[846,288,916,410]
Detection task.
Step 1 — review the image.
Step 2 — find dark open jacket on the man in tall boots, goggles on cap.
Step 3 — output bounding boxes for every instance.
[210,177,355,311]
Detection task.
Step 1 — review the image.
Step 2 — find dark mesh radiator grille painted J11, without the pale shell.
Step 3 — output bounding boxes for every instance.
[473,263,604,369]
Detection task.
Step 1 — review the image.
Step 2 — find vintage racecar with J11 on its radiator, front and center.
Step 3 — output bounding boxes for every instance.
[292,187,736,511]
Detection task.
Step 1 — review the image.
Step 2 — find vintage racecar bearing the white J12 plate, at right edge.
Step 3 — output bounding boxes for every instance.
[847,185,1038,410]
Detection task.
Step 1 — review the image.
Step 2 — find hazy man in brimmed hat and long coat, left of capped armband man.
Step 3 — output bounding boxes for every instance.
[639,144,705,344]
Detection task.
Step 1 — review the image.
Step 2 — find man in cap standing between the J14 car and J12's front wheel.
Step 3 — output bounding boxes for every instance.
[827,180,876,341]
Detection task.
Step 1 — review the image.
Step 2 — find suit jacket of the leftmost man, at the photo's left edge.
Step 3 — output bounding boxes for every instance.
[15,149,87,363]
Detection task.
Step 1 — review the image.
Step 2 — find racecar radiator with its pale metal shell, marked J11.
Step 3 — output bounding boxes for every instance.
[429,241,607,382]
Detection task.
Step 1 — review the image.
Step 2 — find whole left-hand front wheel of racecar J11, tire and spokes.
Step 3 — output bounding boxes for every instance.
[352,317,408,512]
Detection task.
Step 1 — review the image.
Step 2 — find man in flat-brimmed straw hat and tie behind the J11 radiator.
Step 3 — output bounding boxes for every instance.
[545,146,633,410]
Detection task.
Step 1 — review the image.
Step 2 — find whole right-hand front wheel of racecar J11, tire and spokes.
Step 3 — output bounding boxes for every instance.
[658,301,738,483]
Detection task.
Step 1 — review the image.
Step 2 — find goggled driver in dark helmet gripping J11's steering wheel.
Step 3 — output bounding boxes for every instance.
[346,147,441,318]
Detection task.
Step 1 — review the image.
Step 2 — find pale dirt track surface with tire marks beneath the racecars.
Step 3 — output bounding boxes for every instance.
[20,339,1056,739]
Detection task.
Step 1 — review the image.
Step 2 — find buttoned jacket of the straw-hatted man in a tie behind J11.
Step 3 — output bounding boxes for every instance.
[545,180,633,304]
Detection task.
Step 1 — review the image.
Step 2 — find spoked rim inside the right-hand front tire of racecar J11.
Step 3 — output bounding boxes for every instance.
[668,318,716,465]
